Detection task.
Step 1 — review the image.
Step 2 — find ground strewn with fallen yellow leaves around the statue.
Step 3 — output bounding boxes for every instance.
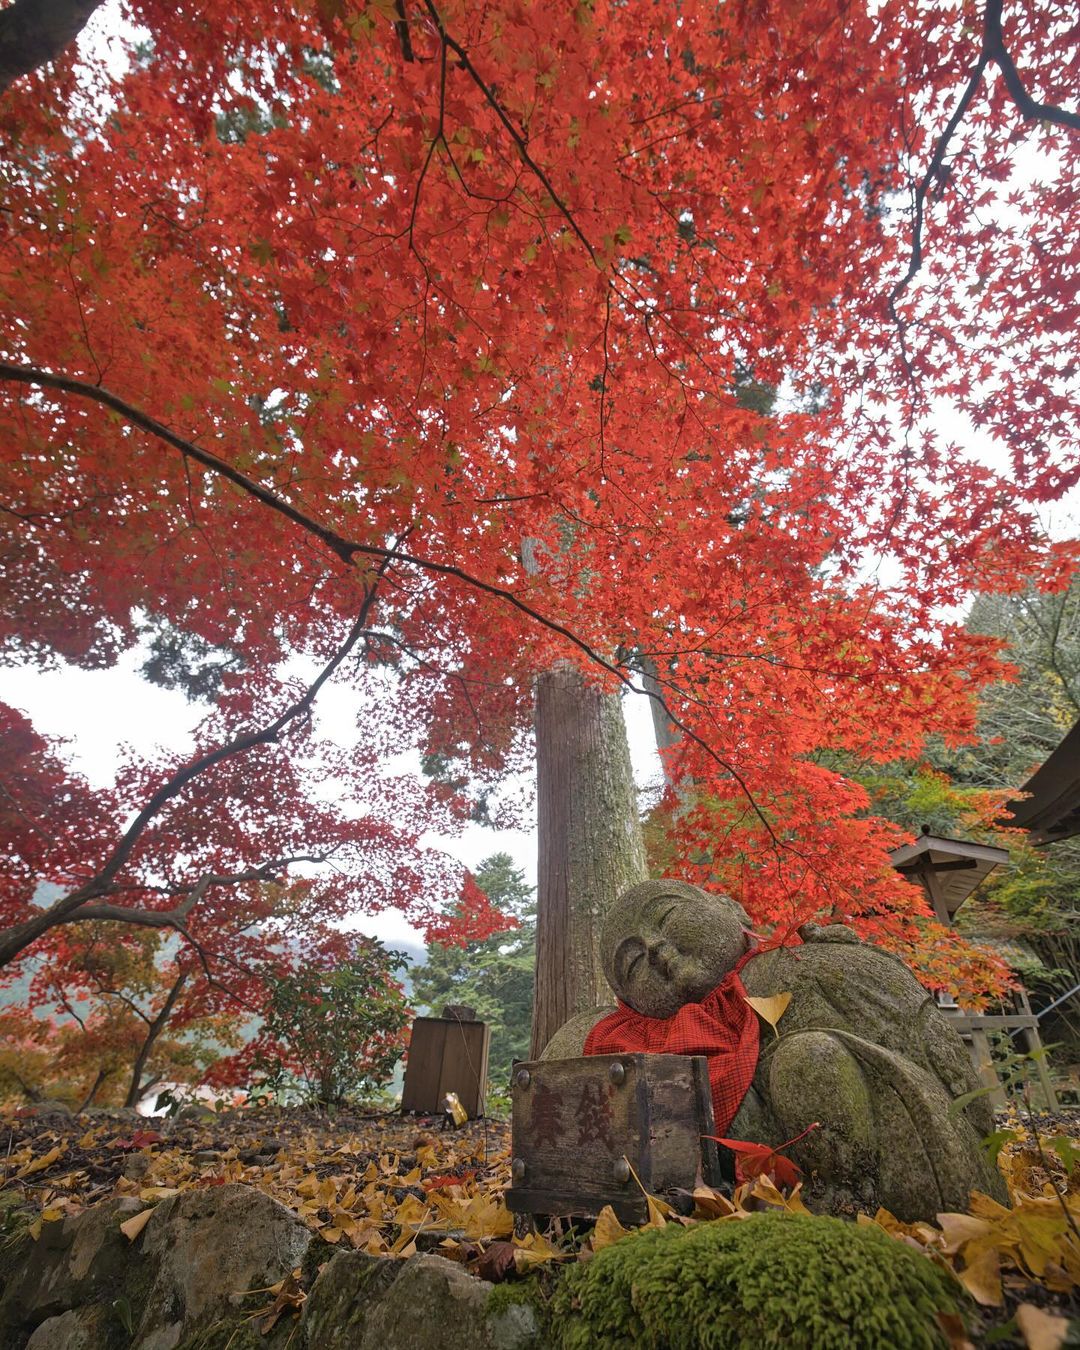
[0,1108,1080,1350]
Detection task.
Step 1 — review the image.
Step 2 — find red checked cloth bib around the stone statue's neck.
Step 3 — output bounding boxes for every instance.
[585,953,759,1134]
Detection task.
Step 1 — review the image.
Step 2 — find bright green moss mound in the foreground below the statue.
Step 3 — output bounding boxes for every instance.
[551,1214,963,1350]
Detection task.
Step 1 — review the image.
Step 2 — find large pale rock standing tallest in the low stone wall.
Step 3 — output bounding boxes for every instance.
[131,1185,312,1350]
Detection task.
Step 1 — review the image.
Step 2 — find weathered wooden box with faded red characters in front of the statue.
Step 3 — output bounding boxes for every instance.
[506,1054,726,1223]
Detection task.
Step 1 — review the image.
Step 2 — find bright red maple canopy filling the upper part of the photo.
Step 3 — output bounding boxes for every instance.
[0,0,1080,1026]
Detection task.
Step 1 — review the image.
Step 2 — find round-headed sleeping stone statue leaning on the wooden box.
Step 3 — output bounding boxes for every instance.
[544,880,1006,1222]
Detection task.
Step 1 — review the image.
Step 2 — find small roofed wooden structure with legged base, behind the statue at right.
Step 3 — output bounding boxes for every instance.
[890,825,1058,1110]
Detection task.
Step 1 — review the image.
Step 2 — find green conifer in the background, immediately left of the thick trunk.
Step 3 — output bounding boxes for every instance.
[413,853,536,1088]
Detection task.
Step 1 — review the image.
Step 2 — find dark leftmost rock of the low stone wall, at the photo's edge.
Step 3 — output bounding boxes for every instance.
[0,1196,144,1331]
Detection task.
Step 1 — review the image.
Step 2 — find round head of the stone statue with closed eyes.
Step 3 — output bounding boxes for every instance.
[601,882,749,1018]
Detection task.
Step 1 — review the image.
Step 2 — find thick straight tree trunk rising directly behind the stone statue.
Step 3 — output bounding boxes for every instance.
[532,662,645,1058]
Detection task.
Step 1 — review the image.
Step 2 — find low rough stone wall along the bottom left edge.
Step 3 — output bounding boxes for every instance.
[0,1185,545,1350]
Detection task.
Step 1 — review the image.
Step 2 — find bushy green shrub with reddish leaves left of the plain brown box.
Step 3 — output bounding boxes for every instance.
[252,938,409,1106]
